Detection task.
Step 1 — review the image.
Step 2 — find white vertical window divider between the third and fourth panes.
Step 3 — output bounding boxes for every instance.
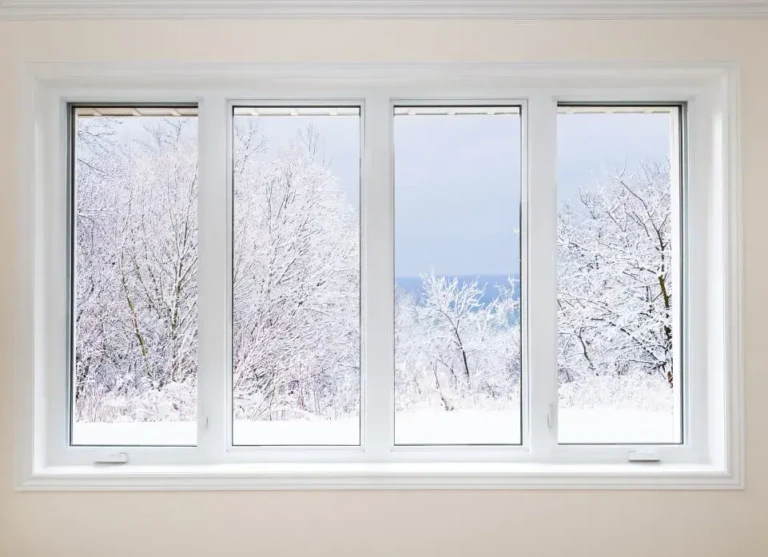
[521,93,557,459]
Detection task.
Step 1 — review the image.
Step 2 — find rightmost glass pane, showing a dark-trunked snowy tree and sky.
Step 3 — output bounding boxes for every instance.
[557,106,681,443]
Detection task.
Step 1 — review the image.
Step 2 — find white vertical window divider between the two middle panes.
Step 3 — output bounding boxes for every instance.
[361,95,395,461]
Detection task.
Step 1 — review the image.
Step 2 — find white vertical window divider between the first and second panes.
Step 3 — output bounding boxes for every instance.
[197,95,232,462]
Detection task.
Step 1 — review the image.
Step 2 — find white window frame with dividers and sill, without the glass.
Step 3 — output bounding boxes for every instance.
[14,63,744,490]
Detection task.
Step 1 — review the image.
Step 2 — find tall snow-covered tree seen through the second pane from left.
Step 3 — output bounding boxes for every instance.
[233,120,360,419]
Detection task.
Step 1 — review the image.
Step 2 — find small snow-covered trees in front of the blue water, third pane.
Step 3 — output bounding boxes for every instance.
[395,273,521,411]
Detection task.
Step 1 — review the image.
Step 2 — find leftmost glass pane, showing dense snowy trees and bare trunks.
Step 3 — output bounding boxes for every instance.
[71,107,197,445]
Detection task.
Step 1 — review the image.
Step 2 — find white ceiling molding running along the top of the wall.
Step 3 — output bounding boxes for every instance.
[0,0,768,20]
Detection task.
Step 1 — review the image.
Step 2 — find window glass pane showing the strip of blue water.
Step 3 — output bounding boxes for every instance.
[394,106,521,444]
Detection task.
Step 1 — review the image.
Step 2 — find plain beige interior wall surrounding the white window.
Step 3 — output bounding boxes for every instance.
[0,21,768,557]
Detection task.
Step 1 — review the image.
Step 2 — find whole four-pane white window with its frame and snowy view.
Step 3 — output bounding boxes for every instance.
[16,64,742,488]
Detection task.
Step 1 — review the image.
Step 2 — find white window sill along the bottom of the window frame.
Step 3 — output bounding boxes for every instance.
[17,463,744,491]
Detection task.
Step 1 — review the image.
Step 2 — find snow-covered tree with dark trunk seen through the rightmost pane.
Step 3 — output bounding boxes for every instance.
[558,164,673,396]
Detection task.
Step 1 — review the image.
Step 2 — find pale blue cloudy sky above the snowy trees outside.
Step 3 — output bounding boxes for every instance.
[236,114,670,277]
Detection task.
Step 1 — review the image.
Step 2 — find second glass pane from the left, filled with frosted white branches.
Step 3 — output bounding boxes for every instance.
[232,107,360,445]
